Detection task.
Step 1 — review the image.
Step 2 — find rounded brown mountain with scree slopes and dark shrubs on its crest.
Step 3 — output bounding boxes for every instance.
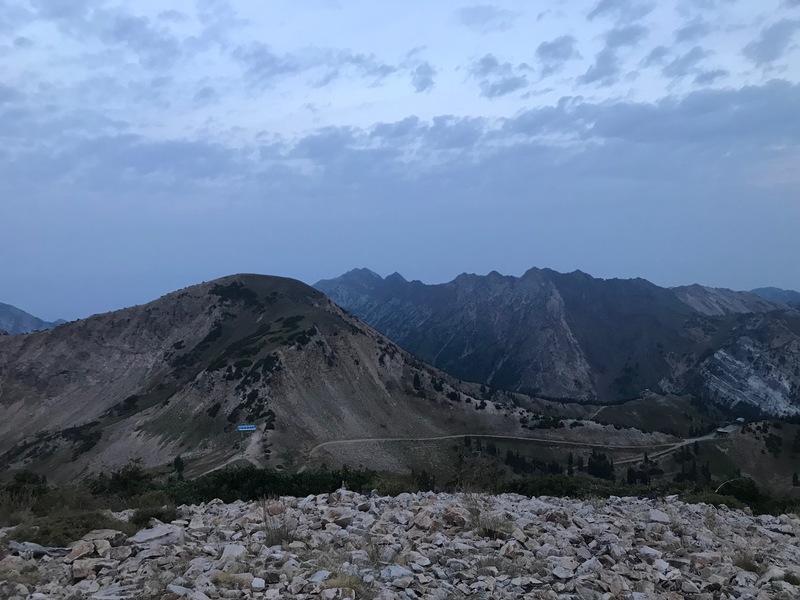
[0,275,524,480]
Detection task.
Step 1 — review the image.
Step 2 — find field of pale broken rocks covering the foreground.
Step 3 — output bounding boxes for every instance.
[0,490,800,600]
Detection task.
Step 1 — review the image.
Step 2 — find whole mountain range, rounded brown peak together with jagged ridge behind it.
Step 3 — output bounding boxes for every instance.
[0,269,800,486]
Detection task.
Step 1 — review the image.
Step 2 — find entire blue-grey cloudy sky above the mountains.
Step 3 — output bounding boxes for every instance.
[0,0,800,320]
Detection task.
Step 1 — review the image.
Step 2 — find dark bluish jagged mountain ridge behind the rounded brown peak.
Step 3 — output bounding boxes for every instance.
[315,269,800,414]
